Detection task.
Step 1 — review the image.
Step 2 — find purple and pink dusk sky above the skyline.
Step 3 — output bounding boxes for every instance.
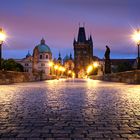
[0,0,140,58]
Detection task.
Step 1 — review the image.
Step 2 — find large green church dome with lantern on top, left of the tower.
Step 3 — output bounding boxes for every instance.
[36,39,51,53]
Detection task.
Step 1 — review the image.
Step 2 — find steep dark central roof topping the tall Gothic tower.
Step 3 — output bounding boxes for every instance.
[77,27,86,43]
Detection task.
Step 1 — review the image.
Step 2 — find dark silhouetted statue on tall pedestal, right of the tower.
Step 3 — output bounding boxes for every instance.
[104,46,111,74]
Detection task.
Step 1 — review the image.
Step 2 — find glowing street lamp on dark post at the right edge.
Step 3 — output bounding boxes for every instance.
[132,29,140,69]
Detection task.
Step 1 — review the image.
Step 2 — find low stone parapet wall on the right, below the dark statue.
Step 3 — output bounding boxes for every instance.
[91,70,140,84]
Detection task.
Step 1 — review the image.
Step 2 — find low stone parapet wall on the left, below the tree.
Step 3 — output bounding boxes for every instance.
[0,71,43,84]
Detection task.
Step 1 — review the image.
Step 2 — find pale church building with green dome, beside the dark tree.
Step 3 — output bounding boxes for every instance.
[16,39,52,75]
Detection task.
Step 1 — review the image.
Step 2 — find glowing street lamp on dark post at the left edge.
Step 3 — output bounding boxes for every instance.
[0,28,6,70]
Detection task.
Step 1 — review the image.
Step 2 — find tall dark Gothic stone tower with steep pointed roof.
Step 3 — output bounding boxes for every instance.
[73,27,93,77]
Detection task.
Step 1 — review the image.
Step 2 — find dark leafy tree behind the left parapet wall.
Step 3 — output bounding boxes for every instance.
[2,59,24,72]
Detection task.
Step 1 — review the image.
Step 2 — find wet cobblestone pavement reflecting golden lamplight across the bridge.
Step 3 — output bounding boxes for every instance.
[0,80,140,140]
